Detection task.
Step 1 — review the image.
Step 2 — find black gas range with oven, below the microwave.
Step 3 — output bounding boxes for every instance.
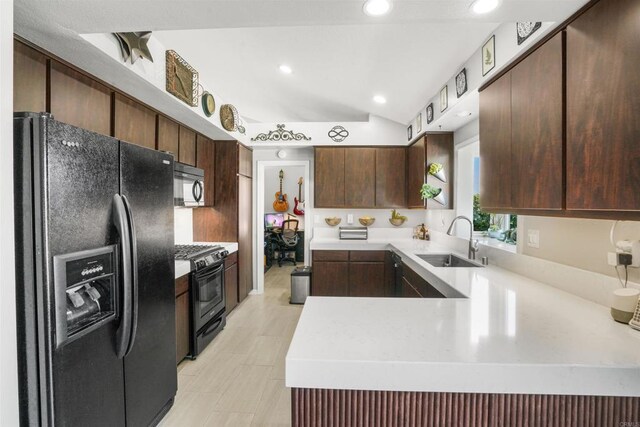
[175,245,229,359]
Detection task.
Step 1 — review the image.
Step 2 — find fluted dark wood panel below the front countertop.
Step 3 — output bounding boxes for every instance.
[291,388,640,427]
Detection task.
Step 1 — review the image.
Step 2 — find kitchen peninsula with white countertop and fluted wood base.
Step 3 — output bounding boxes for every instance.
[286,239,640,425]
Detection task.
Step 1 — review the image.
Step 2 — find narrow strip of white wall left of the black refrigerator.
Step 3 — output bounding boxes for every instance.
[0,0,18,426]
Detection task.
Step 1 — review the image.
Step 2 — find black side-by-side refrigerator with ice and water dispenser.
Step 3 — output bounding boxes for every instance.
[14,113,177,427]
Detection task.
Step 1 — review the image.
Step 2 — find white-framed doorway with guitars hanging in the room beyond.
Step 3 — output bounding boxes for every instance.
[254,160,312,293]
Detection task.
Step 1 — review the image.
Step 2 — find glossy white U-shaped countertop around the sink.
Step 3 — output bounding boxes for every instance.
[286,239,640,396]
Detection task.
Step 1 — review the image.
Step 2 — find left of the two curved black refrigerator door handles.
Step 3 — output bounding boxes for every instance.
[112,194,132,359]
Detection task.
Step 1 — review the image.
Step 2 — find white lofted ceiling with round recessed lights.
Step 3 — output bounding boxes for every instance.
[15,0,586,123]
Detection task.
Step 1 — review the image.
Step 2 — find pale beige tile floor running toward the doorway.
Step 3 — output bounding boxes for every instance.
[160,265,302,427]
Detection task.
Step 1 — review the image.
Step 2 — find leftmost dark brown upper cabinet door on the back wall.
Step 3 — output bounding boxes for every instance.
[314,147,345,208]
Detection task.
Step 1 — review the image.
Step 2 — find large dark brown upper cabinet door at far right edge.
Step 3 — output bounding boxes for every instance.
[566,0,640,211]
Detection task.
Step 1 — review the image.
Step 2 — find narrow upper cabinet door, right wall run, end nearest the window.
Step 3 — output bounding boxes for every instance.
[480,72,511,211]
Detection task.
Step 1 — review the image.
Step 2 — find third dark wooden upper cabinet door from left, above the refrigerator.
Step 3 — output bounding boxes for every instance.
[113,93,156,149]
